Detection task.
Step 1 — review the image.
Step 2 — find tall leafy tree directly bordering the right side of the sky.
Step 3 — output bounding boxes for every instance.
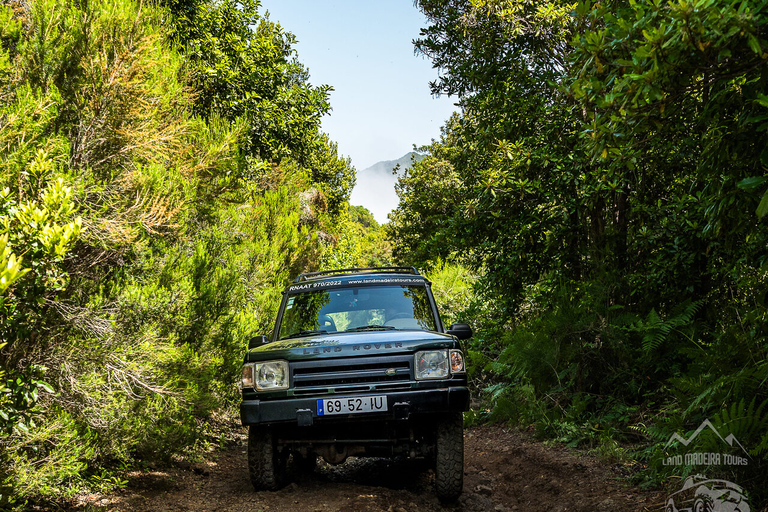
[393,1,588,300]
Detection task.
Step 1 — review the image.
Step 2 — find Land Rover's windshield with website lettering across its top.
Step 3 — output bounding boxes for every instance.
[278,286,437,339]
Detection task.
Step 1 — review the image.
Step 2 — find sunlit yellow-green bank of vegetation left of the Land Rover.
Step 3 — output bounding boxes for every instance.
[0,0,368,508]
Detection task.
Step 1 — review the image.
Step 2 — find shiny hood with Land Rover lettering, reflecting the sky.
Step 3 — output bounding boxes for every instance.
[246,331,458,361]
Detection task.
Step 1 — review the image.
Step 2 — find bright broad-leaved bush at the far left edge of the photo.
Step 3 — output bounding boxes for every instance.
[0,150,81,448]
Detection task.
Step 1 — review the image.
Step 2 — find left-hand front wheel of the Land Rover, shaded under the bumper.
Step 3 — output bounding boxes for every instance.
[248,425,286,491]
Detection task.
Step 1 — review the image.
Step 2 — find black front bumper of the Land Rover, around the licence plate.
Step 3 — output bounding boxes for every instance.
[240,387,469,426]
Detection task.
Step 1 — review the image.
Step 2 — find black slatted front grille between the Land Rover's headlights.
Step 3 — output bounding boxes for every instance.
[291,355,413,395]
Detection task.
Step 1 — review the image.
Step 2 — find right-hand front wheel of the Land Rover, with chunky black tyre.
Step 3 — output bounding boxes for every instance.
[435,413,464,502]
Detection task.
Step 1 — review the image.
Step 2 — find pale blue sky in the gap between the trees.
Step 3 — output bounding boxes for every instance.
[260,0,456,222]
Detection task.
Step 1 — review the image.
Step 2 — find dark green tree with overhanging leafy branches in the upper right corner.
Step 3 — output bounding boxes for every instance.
[570,1,768,308]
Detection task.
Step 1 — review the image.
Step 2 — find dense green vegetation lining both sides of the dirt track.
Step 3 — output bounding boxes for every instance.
[0,0,768,509]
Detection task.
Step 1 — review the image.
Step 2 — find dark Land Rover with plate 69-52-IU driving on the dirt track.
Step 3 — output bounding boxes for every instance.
[240,267,472,500]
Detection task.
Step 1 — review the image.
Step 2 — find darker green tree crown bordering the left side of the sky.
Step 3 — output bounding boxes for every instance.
[169,0,355,211]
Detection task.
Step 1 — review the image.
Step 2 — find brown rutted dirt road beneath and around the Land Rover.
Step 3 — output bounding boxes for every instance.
[73,426,664,512]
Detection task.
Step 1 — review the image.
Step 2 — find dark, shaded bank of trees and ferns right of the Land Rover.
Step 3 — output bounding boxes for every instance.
[389,0,768,505]
